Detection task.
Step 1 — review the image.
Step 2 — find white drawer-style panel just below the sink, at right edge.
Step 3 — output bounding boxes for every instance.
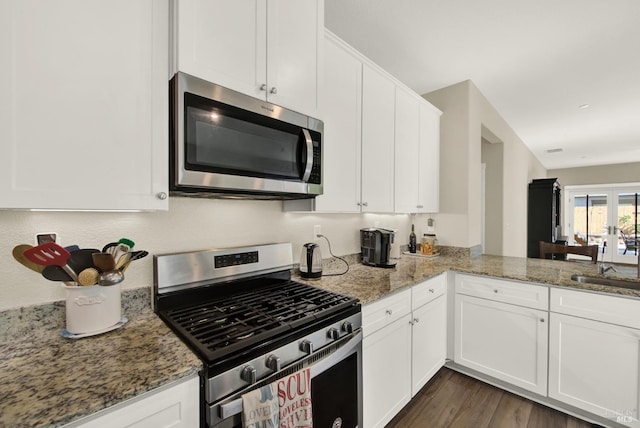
[550,288,640,329]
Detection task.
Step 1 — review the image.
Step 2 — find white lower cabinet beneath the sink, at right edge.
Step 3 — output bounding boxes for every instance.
[549,289,640,427]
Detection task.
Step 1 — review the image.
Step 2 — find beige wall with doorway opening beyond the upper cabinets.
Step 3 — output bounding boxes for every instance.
[423,81,547,257]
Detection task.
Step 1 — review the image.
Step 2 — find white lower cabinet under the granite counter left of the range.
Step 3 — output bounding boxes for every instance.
[65,375,200,428]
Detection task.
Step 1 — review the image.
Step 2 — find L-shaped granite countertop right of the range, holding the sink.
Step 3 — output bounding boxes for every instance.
[295,255,640,304]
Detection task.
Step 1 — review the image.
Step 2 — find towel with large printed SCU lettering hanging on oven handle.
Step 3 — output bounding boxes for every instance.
[277,368,313,428]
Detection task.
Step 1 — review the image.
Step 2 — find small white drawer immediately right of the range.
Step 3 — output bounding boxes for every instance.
[362,288,411,337]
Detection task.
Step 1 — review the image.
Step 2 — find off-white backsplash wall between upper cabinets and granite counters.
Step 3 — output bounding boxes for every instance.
[0,197,410,310]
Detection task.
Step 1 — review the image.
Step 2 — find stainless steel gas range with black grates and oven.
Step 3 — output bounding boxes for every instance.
[154,243,362,428]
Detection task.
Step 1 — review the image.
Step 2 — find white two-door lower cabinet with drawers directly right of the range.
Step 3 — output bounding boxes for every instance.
[362,274,447,428]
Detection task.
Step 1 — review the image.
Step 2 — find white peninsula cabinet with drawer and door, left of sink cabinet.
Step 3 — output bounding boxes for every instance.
[454,275,549,395]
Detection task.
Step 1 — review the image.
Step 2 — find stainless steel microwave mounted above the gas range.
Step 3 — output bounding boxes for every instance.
[169,72,323,199]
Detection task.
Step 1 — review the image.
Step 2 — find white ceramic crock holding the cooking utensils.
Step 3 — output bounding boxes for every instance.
[62,284,122,334]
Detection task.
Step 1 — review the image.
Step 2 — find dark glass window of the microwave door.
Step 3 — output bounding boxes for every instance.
[185,93,306,181]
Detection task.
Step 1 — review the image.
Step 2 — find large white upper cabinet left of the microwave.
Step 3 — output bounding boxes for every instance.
[0,0,169,210]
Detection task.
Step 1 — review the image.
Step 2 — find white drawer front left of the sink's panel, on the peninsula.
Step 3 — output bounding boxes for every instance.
[456,275,549,310]
